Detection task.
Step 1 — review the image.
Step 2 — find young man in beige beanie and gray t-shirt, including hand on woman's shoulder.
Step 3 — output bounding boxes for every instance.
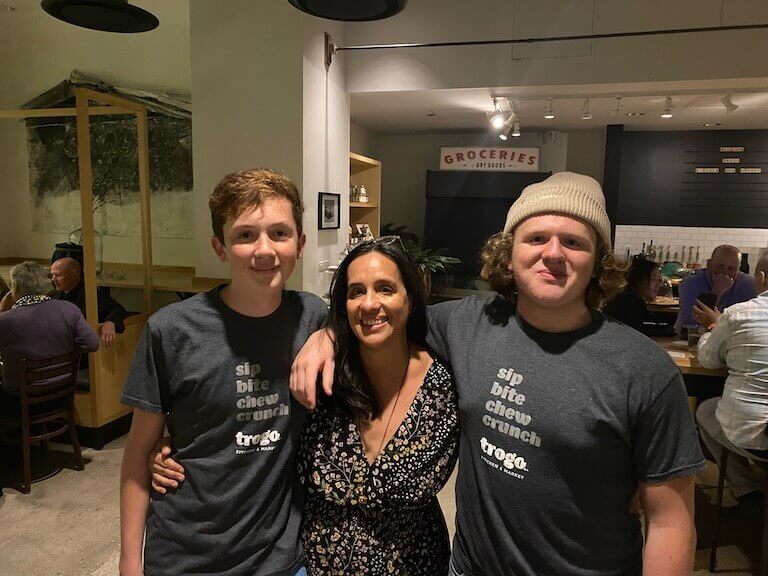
[292,173,704,576]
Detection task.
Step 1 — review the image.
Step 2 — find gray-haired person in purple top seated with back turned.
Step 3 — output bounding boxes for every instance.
[0,261,99,404]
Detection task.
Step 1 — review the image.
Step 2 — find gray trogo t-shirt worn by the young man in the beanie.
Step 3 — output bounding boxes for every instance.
[428,297,704,576]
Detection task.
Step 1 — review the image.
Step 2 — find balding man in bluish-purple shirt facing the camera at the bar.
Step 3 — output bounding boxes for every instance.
[675,244,757,333]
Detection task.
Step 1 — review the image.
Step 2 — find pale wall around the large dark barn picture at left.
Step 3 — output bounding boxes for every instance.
[0,0,194,265]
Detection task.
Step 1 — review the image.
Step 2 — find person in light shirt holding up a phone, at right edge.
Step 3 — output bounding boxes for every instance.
[694,256,768,498]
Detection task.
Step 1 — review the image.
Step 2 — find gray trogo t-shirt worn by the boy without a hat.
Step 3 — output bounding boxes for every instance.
[122,288,326,576]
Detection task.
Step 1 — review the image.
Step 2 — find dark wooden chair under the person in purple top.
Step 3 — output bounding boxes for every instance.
[0,352,85,494]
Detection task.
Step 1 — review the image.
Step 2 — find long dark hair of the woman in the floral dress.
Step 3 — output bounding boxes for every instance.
[327,241,427,419]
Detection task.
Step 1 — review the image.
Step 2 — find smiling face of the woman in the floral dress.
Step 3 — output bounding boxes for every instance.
[347,252,411,348]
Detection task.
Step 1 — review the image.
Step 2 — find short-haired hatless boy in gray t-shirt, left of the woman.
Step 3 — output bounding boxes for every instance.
[120,170,326,576]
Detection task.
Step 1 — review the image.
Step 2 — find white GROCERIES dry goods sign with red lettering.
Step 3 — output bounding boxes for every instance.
[440,146,539,172]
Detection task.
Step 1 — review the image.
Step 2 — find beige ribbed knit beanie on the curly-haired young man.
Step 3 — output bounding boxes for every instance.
[504,172,611,250]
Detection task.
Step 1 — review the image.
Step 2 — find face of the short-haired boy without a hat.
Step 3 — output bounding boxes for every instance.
[211,197,305,291]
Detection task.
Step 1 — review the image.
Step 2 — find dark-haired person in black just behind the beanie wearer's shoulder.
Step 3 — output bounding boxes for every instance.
[603,256,672,336]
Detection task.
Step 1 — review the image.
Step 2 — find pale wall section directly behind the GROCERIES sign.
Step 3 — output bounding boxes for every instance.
[377,132,570,238]
